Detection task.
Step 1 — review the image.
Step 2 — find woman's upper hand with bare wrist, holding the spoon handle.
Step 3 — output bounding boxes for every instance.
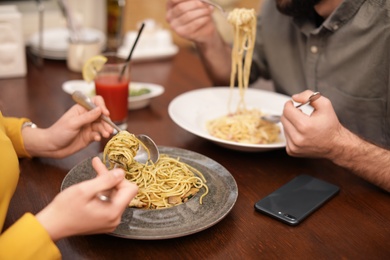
[22,96,113,158]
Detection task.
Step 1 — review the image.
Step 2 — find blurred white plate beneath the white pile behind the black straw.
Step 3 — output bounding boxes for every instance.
[117,45,179,61]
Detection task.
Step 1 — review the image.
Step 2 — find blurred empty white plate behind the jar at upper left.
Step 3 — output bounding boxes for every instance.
[28,27,106,60]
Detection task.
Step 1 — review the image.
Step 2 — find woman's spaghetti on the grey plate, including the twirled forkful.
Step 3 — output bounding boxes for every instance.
[103,131,208,209]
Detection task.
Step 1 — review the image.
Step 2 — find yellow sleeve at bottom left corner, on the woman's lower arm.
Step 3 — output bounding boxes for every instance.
[0,213,61,260]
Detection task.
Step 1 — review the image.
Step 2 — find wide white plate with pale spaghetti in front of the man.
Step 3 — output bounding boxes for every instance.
[168,87,291,152]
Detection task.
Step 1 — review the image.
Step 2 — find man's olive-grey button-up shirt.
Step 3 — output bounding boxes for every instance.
[251,0,390,147]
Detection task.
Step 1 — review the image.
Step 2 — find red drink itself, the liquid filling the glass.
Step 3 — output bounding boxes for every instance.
[95,74,129,123]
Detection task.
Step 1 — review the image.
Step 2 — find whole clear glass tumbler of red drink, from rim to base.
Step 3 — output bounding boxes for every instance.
[95,52,130,129]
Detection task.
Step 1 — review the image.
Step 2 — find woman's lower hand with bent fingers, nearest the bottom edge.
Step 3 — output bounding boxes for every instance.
[36,157,138,241]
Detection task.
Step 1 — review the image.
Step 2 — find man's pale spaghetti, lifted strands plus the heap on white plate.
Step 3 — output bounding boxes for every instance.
[206,8,280,144]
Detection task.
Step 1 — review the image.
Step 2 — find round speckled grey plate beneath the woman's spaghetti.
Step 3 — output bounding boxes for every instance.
[61,145,238,240]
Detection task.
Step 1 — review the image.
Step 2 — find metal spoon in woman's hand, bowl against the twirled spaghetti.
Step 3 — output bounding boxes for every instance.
[72,90,160,164]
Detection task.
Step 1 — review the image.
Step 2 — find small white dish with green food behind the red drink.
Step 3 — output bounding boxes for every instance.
[62,80,165,110]
